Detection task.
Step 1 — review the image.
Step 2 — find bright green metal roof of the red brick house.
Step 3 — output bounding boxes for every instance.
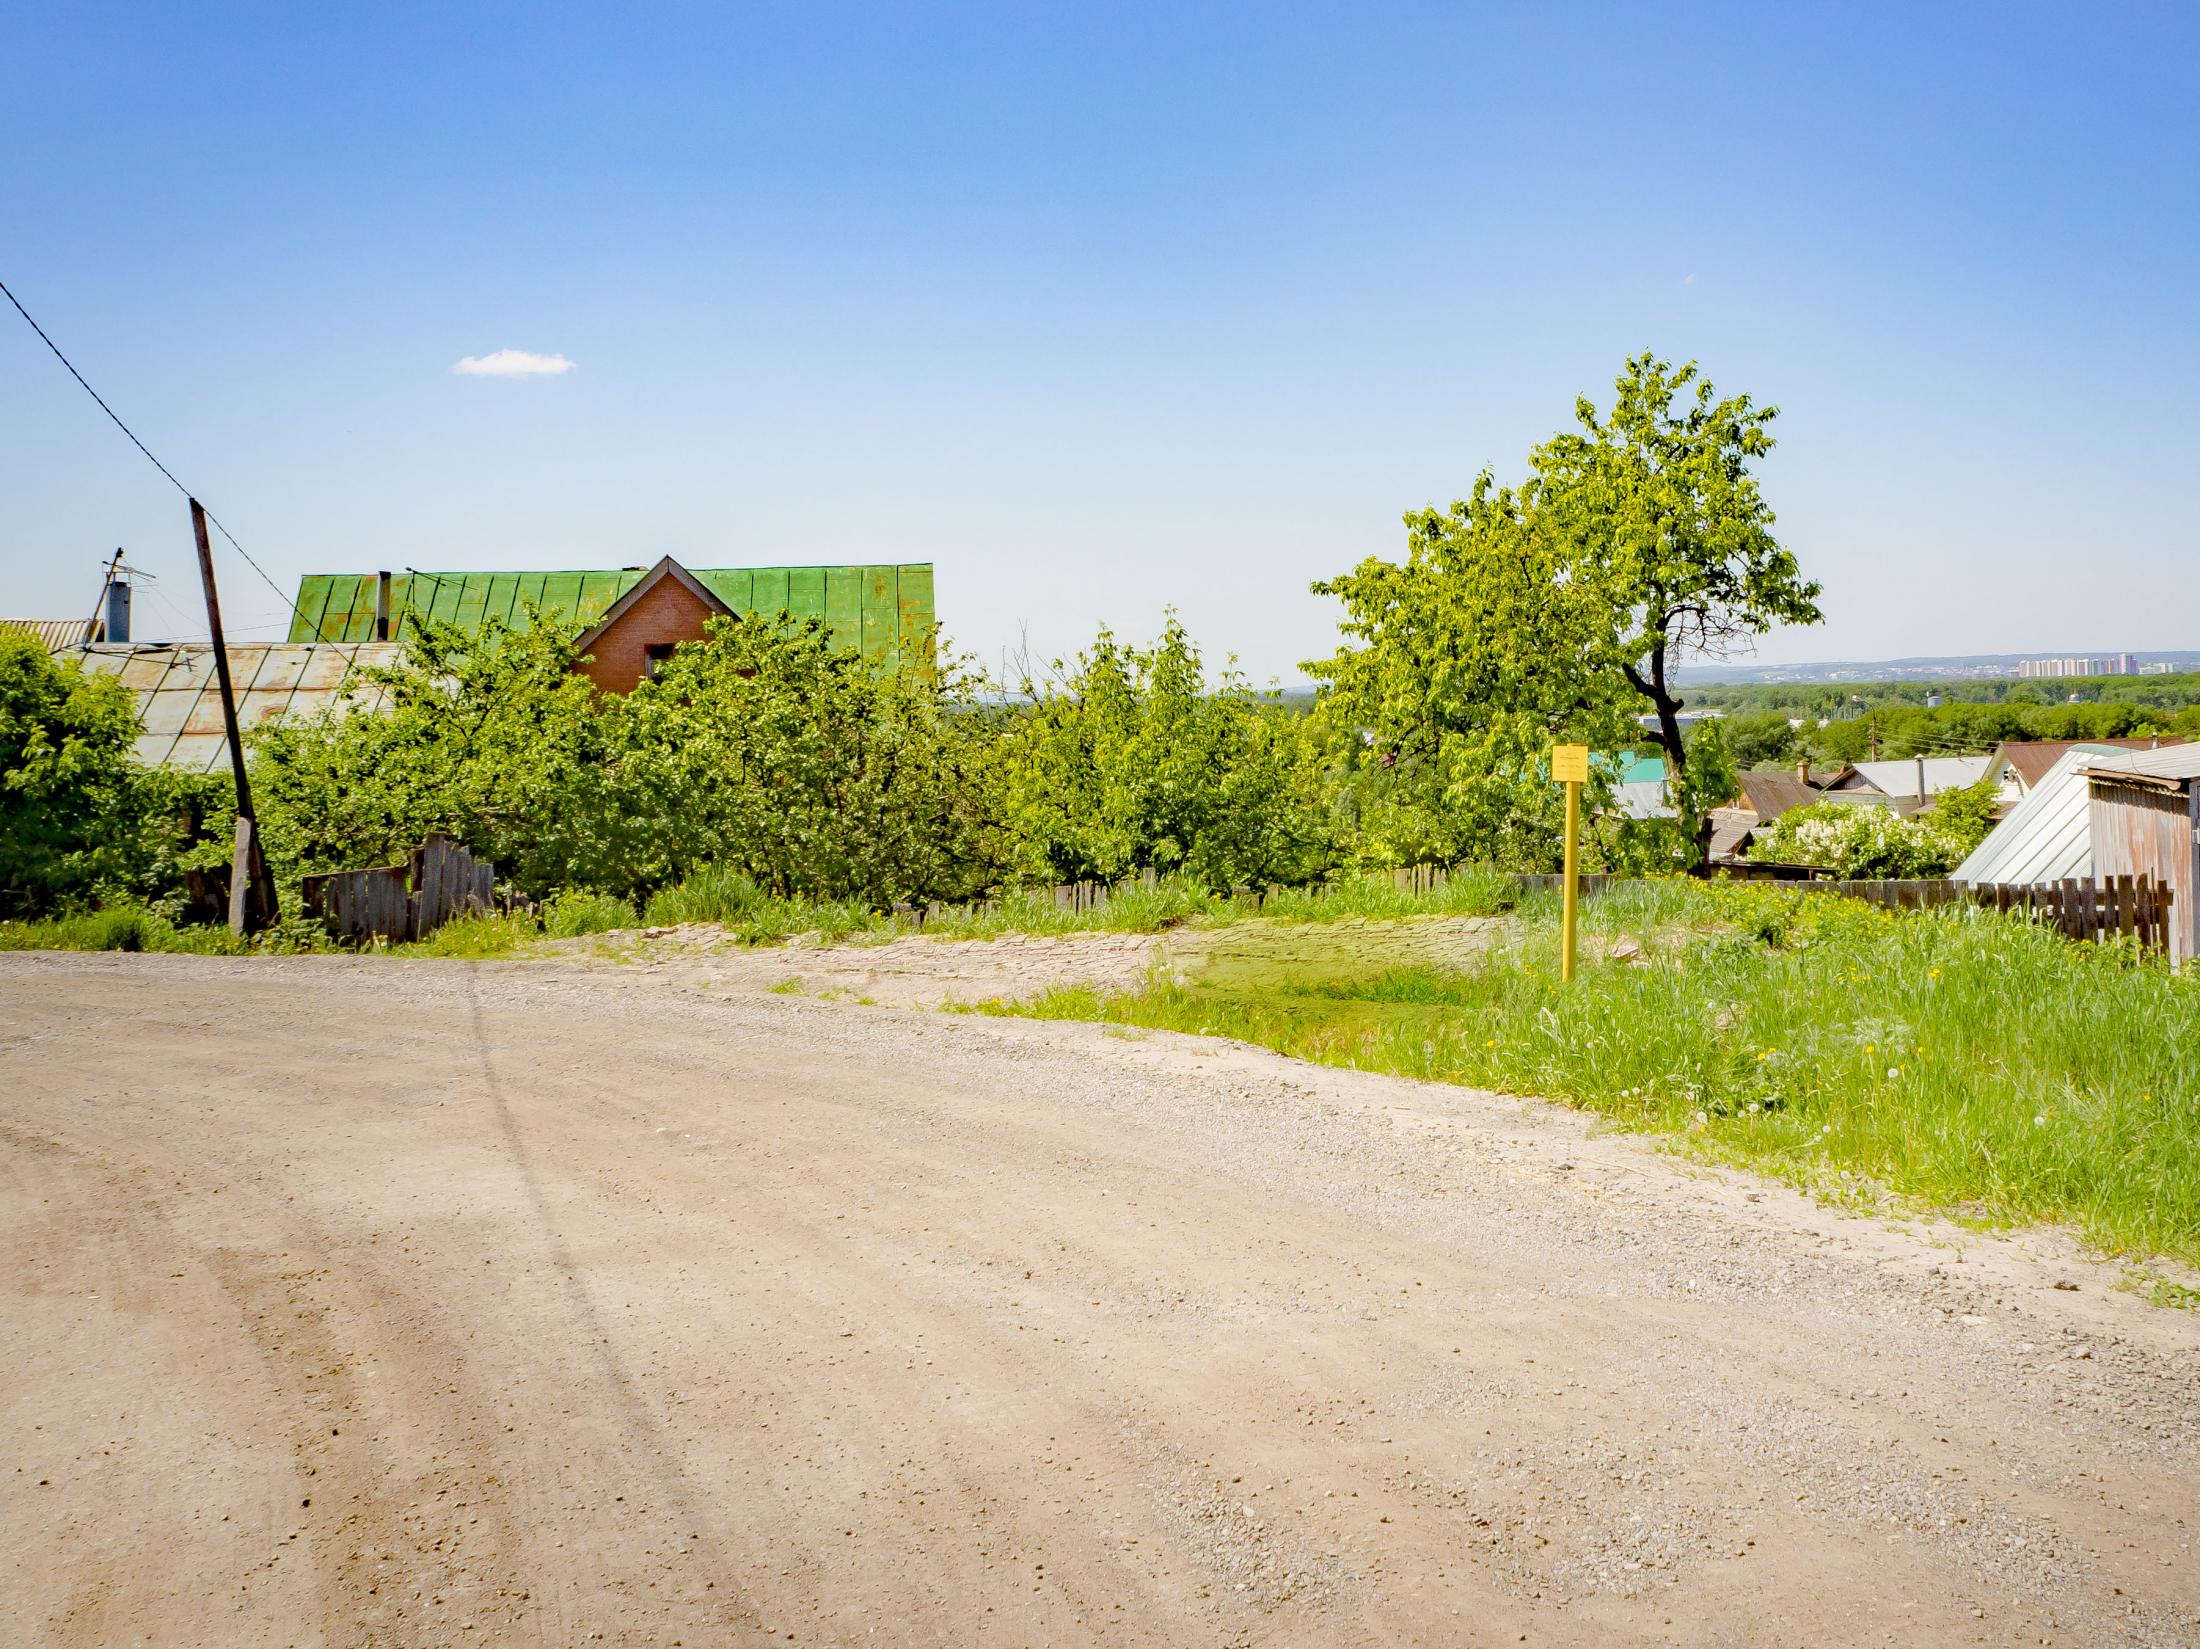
[290,561,933,664]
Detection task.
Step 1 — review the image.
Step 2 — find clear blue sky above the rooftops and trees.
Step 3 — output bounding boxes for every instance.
[0,4,2200,679]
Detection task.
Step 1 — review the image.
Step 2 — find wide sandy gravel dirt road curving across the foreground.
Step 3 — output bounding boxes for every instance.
[0,956,2200,1649]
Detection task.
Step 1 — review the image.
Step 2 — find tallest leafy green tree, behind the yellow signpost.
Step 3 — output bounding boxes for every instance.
[1307,354,1819,857]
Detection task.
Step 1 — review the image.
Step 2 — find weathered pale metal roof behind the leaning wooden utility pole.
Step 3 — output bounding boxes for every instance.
[67,642,398,772]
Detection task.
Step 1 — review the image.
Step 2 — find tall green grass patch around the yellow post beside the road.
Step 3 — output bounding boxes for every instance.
[992,882,2200,1262]
